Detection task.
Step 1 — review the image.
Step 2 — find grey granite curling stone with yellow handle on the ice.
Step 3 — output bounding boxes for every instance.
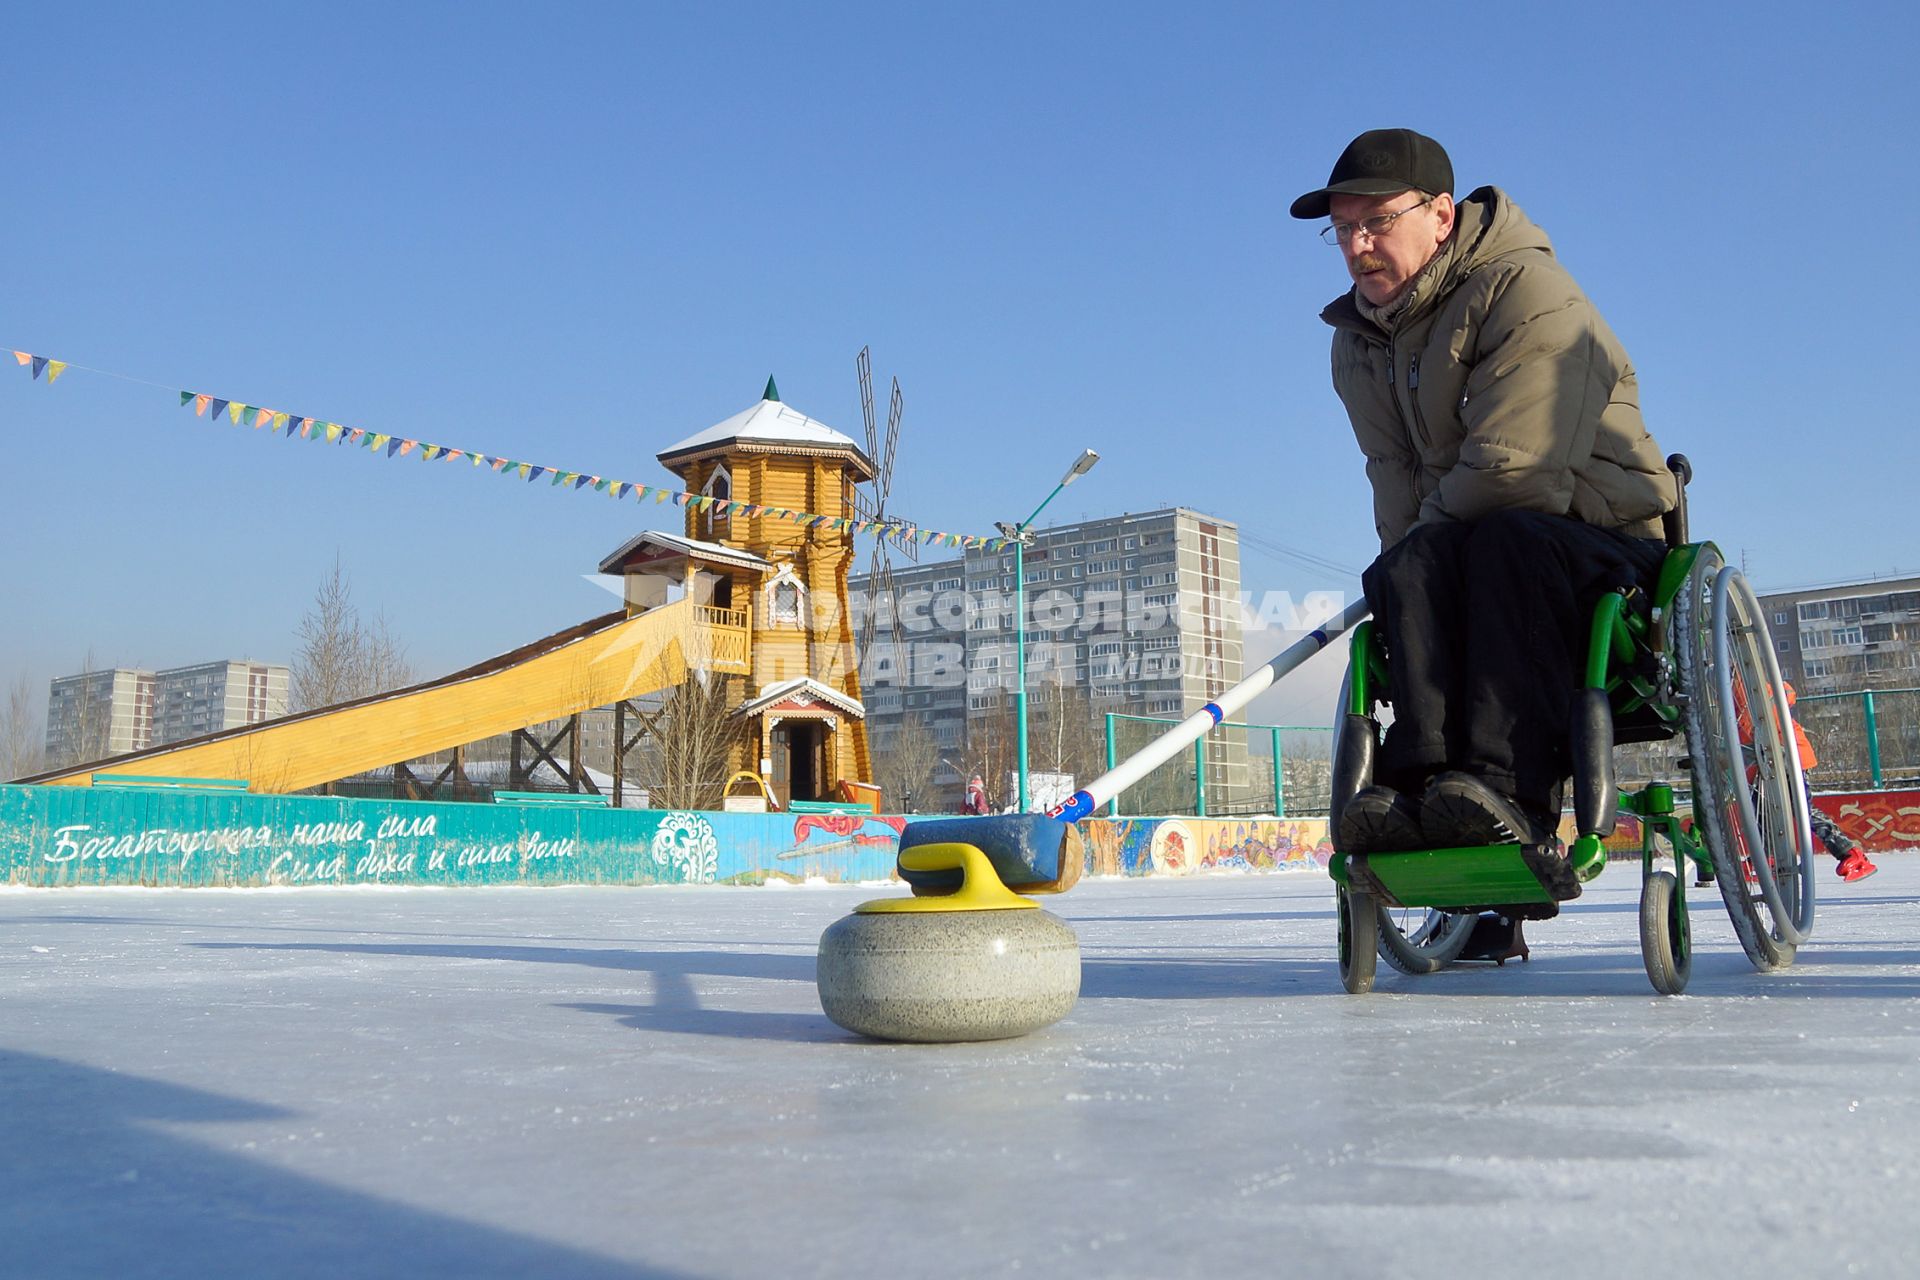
[816,844,1079,1044]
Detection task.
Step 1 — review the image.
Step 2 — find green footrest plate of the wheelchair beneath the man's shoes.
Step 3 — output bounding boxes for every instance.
[1344,841,1580,915]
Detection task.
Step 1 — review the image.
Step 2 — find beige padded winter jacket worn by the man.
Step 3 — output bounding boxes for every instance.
[1321,186,1674,549]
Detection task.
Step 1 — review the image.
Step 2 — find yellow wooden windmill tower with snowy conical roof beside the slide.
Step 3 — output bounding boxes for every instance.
[601,378,874,804]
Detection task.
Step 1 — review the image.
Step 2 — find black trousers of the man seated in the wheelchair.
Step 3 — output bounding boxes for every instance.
[1361,510,1667,814]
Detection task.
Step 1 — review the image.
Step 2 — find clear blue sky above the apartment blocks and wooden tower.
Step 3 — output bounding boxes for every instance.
[0,2,1920,721]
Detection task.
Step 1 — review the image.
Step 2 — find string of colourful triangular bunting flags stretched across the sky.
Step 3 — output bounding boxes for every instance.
[13,351,1010,551]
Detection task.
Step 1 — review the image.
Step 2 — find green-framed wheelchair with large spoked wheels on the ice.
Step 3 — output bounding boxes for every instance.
[1329,453,1814,996]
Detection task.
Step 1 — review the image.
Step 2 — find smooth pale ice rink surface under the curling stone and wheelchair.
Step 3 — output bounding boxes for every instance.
[0,854,1920,1280]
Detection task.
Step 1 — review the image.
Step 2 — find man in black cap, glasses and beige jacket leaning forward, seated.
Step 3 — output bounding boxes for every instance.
[1292,129,1678,852]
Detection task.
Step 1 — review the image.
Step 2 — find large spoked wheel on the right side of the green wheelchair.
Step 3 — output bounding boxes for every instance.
[1672,543,1814,969]
